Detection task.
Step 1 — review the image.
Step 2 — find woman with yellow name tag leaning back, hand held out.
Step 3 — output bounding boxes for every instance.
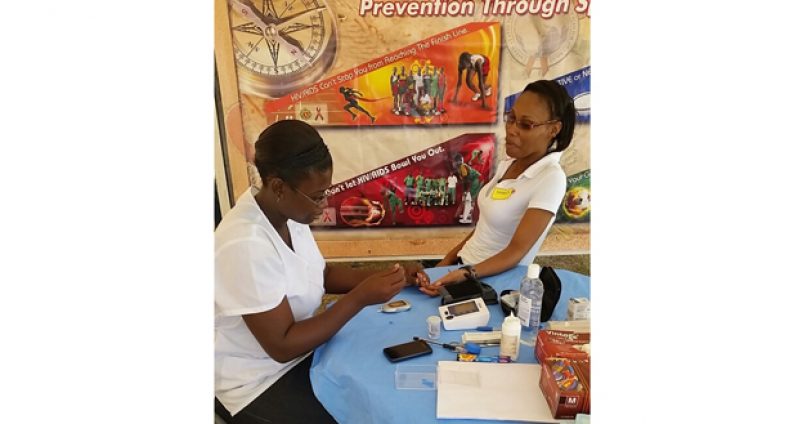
[420,80,576,296]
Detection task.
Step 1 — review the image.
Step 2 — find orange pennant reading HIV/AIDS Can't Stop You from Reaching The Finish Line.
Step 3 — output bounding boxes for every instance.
[264,23,501,126]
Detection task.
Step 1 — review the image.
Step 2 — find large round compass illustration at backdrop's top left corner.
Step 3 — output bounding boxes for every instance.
[228,0,338,98]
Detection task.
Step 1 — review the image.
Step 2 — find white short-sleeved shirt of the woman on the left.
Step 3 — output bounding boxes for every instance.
[214,188,325,415]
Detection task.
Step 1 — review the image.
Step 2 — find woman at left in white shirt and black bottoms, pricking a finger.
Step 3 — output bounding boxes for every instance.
[215,120,428,424]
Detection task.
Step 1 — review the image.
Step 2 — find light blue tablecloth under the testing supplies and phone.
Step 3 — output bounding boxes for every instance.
[310,267,590,424]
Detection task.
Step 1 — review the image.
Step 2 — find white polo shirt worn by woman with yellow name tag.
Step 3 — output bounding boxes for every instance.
[458,152,565,266]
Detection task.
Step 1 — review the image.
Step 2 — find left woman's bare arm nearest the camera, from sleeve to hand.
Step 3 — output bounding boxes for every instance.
[243,266,405,363]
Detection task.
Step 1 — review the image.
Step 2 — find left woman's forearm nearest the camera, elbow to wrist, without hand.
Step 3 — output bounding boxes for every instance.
[260,293,365,363]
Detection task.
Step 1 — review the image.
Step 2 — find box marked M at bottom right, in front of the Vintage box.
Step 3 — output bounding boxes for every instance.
[539,358,589,419]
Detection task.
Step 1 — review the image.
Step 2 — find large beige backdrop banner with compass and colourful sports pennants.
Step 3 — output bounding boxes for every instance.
[222,0,590,238]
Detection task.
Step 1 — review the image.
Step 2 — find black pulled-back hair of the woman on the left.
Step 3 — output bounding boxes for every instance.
[254,119,332,186]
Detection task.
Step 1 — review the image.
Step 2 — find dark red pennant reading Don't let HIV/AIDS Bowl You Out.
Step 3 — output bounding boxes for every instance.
[313,134,495,228]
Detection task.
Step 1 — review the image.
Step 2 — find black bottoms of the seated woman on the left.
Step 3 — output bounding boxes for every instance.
[214,355,336,424]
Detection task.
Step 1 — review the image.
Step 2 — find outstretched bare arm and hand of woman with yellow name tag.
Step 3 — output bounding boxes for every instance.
[421,209,554,296]
